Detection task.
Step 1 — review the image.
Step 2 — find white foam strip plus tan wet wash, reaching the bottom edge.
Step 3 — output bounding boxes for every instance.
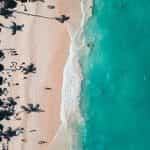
[50,0,92,150]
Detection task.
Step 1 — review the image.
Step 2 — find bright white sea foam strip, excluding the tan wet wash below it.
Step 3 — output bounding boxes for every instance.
[61,0,92,126]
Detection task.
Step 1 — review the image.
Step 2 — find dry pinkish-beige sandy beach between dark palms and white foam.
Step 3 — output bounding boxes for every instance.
[0,0,81,150]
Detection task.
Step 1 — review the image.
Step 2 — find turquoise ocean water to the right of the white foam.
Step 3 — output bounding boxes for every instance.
[80,0,150,150]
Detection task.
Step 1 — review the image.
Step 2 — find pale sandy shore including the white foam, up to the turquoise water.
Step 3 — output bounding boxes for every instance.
[1,0,92,150]
